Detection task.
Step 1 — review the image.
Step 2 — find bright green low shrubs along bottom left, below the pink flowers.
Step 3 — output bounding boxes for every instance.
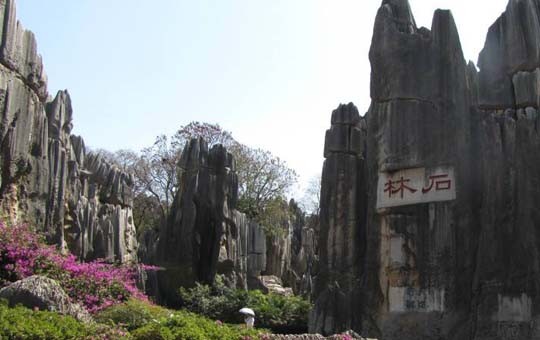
[0,299,267,340]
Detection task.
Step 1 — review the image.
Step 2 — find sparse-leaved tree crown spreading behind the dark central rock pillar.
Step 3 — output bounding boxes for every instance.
[97,122,298,233]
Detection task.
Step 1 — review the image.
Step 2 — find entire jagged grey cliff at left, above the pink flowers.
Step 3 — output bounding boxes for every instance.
[0,0,137,262]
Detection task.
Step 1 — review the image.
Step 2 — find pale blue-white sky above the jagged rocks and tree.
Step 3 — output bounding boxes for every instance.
[17,0,507,197]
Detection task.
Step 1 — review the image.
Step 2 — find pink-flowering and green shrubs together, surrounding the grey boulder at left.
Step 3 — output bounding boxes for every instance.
[0,222,276,340]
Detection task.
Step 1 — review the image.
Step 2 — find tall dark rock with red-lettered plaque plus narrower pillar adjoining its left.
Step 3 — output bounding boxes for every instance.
[312,1,474,339]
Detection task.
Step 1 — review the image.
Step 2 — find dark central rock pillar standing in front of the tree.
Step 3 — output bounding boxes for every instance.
[155,139,266,304]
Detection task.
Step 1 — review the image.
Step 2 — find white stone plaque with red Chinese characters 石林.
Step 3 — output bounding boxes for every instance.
[377,167,456,209]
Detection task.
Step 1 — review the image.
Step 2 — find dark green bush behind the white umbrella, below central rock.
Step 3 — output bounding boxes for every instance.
[179,280,311,334]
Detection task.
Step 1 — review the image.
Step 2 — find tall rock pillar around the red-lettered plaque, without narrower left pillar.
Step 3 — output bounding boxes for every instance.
[363,1,478,339]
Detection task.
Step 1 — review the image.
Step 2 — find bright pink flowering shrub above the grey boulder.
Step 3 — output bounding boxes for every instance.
[0,222,147,313]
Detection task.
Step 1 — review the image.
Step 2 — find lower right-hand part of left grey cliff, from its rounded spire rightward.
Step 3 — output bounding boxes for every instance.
[42,91,137,263]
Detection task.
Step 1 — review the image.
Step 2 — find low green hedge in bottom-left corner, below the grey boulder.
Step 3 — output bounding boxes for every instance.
[0,300,129,340]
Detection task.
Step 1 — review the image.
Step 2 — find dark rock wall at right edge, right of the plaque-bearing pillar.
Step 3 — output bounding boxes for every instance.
[473,0,540,339]
